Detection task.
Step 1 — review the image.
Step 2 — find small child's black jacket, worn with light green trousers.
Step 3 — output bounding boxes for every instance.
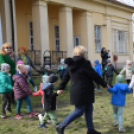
[44,85,58,111]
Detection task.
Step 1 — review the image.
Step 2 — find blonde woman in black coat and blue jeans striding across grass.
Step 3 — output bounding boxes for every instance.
[56,46,107,134]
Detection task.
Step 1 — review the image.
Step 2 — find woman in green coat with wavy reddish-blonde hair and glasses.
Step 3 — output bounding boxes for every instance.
[0,43,16,104]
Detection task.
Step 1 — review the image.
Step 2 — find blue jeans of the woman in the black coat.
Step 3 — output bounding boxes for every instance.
[60,104,94,129]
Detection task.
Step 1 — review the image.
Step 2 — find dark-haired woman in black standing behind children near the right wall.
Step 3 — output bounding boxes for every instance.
[101,47,110,70]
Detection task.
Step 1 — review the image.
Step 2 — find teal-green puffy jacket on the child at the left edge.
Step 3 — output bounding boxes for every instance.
[0,72,13,93]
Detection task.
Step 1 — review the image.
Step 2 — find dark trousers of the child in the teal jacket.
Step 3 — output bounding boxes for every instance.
[0,92,12,115]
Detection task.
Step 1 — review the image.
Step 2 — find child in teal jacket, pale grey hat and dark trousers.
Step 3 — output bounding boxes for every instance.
[0,63,13,119]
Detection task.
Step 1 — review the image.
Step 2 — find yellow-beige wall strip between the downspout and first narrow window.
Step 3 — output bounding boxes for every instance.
[16,0,32,49]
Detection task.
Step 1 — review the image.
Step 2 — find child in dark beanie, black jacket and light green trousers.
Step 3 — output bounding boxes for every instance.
[39,74,58,128]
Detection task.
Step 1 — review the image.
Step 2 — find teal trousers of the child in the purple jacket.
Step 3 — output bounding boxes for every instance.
[16,96,32,113]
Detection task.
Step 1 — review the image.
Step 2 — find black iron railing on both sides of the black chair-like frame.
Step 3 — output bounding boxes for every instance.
[27,50,67,65]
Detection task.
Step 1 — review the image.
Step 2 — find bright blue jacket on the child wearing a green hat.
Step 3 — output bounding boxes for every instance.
[108,83,132,106]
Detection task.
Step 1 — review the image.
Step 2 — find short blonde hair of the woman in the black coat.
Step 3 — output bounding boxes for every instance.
[73,45,87,58]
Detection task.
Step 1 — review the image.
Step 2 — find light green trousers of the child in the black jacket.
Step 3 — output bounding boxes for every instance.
[41,110,58,126]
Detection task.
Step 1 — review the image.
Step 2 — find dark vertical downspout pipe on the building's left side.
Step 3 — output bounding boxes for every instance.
[9,0,15,52]
